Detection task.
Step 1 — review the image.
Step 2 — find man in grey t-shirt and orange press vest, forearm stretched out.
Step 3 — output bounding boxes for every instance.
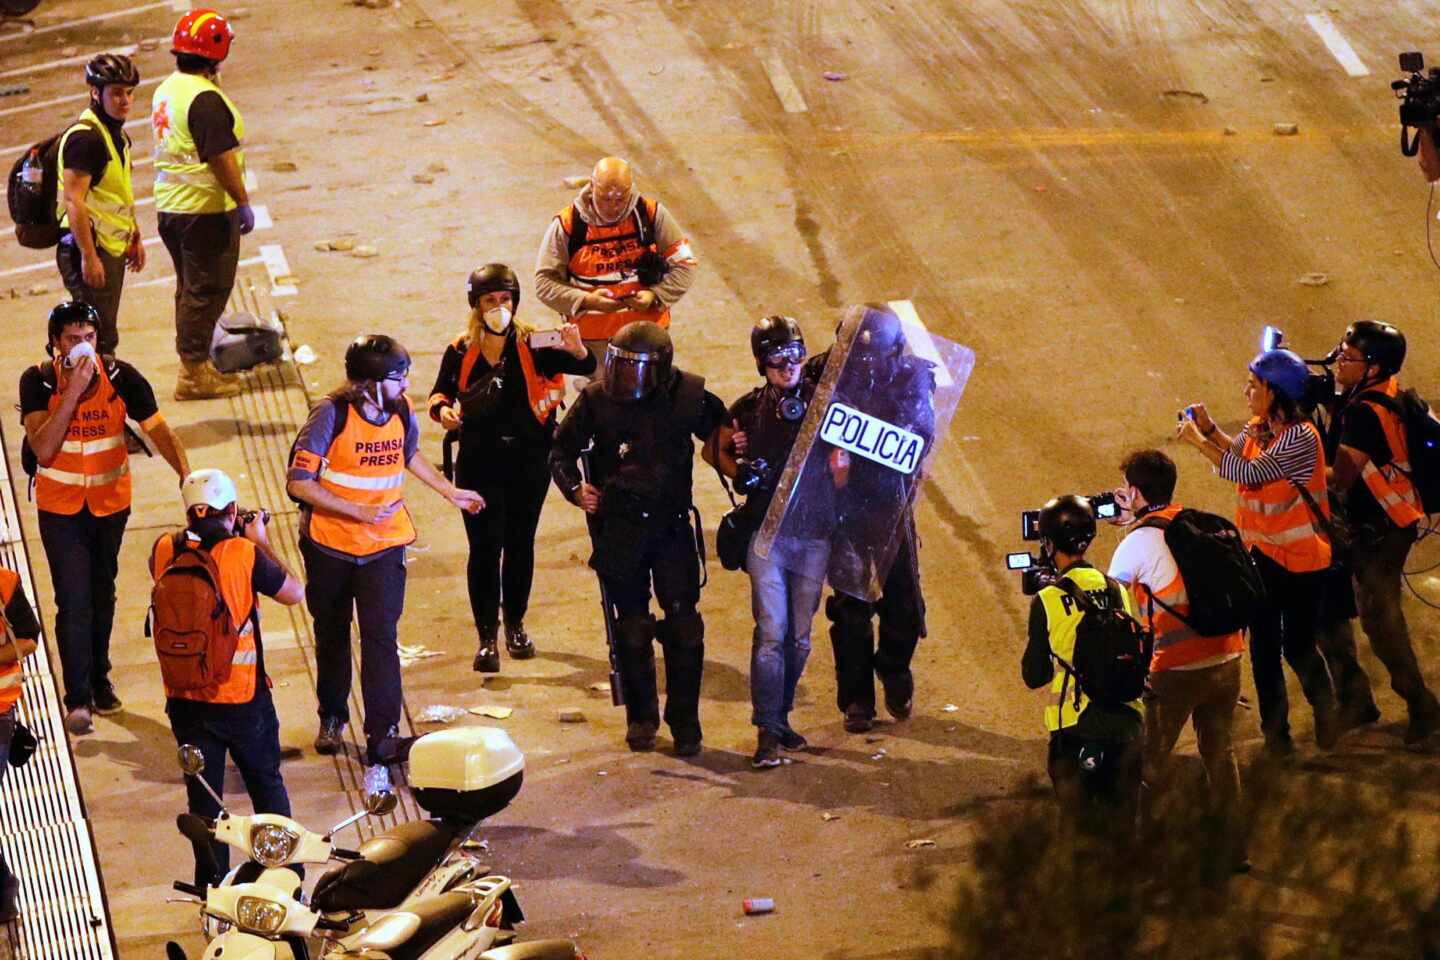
[285,334,485,793]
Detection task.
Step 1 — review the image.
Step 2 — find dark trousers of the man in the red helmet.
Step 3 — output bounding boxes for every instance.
[160,210,240,363]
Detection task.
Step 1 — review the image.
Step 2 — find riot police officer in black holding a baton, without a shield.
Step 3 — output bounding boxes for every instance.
[550,321,726,757]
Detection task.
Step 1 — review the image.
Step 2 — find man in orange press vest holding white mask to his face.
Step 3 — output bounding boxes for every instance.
[20,301,190,735]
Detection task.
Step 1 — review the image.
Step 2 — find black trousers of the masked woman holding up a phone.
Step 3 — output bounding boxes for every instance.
[455,439,550,633]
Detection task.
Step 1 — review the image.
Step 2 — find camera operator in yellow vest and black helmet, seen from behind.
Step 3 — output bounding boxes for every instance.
[1020,495,1143,842]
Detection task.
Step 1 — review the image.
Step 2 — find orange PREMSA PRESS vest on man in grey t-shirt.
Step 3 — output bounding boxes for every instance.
[308,399,415,557]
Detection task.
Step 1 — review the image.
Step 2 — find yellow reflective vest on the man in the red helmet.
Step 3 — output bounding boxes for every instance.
[150,71,245,213]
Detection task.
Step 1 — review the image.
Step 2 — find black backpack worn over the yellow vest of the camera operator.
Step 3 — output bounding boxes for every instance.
[1051,577,1155,708]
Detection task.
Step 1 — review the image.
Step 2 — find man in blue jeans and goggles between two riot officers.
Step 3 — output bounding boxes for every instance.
[701,315,832,770]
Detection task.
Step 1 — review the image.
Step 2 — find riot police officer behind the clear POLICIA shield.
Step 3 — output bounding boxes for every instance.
[806,304,935,733]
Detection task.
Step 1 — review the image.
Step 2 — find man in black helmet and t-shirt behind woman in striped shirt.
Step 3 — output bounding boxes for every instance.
[1326,320,1440,744]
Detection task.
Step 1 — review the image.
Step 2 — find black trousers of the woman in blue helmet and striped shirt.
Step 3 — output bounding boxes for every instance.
[1250,550,1335,744]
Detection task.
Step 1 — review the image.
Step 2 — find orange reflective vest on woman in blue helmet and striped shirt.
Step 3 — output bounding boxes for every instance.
[1236,417,1331,573]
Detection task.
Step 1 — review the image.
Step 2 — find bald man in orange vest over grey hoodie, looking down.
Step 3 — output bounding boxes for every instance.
[536,157,696,357]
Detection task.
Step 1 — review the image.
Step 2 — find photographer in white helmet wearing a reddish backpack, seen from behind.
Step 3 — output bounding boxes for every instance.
[150,469,305,885]
